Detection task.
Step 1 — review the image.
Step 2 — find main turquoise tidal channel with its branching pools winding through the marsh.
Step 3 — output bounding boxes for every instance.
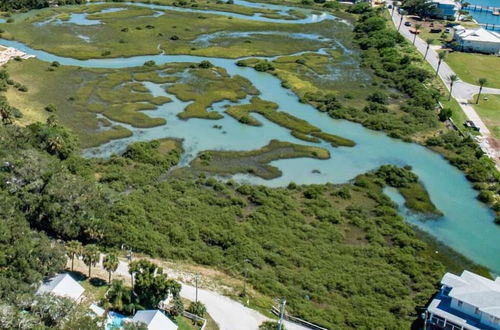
[0,1,500,273]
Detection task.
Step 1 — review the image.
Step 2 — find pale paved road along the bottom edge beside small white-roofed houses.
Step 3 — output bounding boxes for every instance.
[114,260,307,330]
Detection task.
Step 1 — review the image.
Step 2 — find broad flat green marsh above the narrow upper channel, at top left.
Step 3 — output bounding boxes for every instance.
[2,4,342,59]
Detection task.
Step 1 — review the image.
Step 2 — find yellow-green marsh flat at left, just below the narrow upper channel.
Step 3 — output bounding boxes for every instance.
[7,59,259,147]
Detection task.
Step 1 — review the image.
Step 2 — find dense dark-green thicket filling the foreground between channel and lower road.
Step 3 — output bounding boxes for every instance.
[0,118,443,329]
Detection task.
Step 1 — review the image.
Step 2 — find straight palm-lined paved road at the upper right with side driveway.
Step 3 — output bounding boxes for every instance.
[389,3,500,138]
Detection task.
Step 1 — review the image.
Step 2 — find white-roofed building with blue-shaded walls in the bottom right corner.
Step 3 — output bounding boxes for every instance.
[427,271,500,330]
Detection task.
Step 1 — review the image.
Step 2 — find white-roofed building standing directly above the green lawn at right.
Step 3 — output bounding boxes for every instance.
[453,25,500,54]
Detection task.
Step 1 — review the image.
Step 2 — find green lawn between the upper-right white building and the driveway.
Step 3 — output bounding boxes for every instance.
[446,52,500,88]
